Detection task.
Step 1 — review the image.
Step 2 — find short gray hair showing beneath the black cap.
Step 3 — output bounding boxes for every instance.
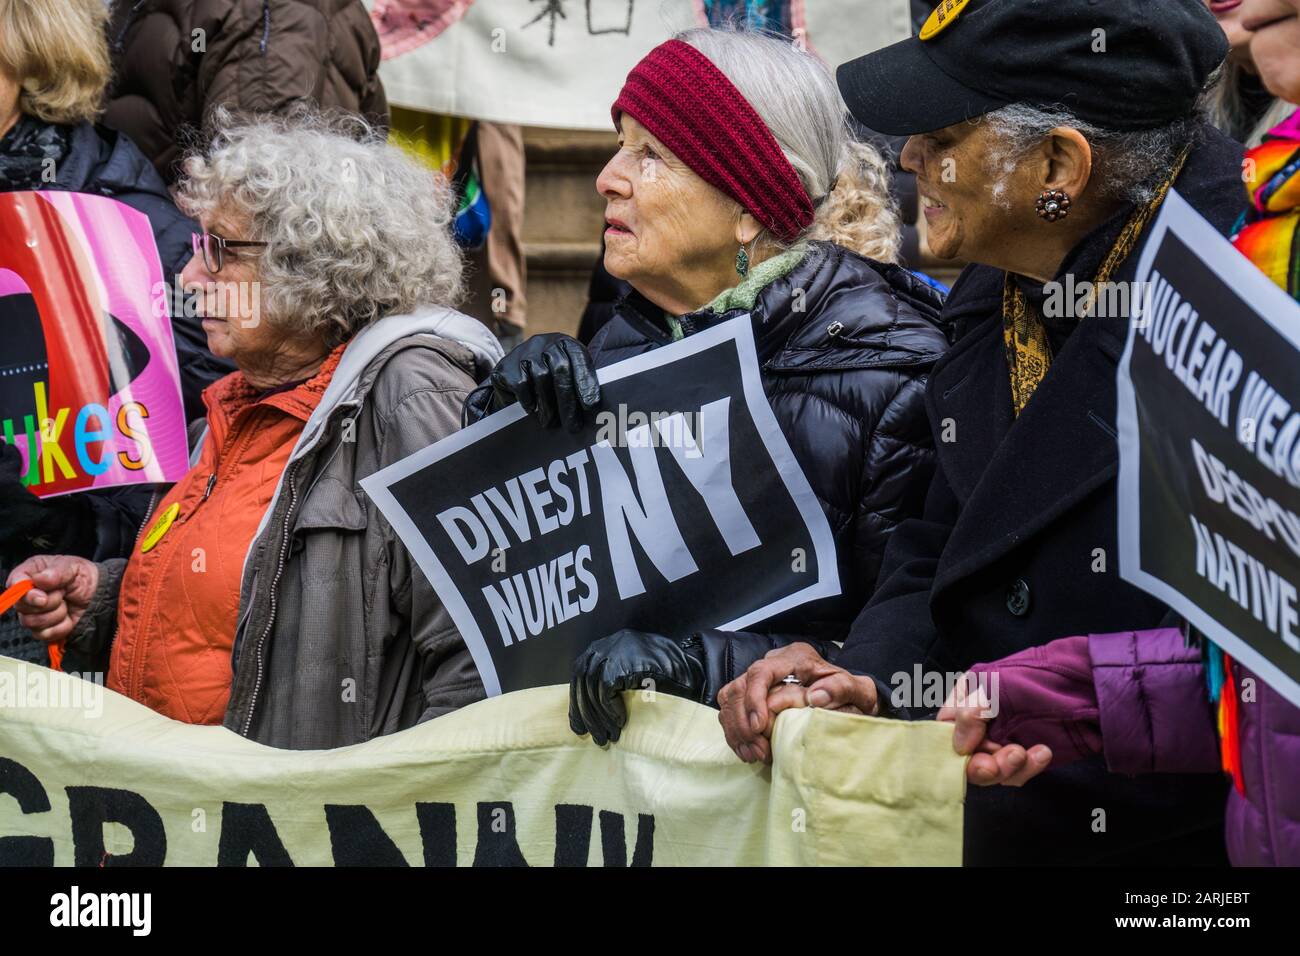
[971,103,1201,207]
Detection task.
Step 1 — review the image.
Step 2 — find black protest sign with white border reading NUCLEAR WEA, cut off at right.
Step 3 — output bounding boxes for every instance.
[1118,193,1300,705]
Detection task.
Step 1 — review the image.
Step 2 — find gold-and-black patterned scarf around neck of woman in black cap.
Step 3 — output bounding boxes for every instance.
[1002,146,1192,418]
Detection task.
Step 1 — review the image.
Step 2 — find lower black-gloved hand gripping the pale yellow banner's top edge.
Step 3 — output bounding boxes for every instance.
[569,628,705,747]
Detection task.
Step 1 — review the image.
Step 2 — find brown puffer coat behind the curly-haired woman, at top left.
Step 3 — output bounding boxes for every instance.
[104,0,389,183]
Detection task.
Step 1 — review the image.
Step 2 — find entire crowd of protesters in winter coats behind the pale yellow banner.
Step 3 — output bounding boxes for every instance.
[0,0,1300,865]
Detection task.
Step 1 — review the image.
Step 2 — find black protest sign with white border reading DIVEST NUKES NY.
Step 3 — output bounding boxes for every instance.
[361,315,840,695]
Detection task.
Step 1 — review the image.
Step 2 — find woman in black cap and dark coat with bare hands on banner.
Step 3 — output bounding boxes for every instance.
[719,0,1242,865]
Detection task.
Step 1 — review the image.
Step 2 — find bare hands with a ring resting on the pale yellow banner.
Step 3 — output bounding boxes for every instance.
[718,644,879,763]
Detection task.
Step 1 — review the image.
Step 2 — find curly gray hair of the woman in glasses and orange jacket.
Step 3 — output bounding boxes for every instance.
[177,109,464,347]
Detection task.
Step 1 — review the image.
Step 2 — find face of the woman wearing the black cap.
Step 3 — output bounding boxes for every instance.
[900,122,1037,263]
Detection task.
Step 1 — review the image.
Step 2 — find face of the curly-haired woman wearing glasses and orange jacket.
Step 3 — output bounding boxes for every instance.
[181,215,276,368]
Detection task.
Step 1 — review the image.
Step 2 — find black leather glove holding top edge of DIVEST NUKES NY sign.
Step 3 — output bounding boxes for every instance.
[464,332,601,432]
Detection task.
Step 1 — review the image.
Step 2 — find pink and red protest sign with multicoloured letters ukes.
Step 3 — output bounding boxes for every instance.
[0,190,189,497]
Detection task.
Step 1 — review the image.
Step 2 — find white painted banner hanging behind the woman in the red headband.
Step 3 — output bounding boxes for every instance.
[367,0,911,131]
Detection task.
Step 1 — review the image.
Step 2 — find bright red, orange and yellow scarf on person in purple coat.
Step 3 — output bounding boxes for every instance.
[1204,113,1300,796]
